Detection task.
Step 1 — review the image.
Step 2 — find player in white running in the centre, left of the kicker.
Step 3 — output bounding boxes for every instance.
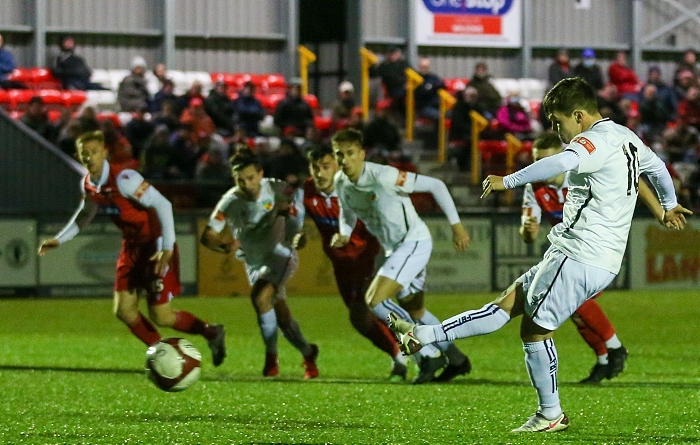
[331,129,471,384]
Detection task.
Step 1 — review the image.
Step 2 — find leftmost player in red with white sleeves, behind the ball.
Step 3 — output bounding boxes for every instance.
[39,131,226,366]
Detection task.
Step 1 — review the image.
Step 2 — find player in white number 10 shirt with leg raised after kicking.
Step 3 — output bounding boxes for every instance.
[390,78,692,432]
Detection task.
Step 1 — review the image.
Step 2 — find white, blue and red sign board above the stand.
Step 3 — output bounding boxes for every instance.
[413,0,522,48]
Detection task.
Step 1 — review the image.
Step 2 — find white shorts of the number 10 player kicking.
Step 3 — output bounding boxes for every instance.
[515,246,615,331]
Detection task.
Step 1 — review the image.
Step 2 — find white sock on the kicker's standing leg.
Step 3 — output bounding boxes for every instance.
[523,338,562,420]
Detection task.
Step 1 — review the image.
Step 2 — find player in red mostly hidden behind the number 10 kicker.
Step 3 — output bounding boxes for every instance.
[520,132,663,384]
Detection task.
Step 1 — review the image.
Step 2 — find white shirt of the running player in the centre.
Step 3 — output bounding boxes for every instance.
[334,162,430,255]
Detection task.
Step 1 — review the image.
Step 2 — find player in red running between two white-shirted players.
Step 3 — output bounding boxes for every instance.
[302,146,407,381]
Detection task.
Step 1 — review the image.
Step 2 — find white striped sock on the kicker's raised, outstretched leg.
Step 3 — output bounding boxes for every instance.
[424,303,510,342]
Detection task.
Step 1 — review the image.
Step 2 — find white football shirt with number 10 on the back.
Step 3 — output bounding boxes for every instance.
[548,119,660,274]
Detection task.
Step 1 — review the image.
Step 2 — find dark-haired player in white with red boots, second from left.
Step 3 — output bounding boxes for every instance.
[202,150,318,379]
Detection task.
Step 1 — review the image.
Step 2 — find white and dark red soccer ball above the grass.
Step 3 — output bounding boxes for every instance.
[146,338,202,392]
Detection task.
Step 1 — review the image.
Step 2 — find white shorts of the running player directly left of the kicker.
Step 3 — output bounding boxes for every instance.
[377,238,433,299]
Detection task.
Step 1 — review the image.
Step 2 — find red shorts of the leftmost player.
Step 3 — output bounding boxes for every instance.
[114,240,181,305]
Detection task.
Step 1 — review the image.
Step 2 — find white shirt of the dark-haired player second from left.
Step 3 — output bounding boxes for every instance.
[208,178,294,266]
